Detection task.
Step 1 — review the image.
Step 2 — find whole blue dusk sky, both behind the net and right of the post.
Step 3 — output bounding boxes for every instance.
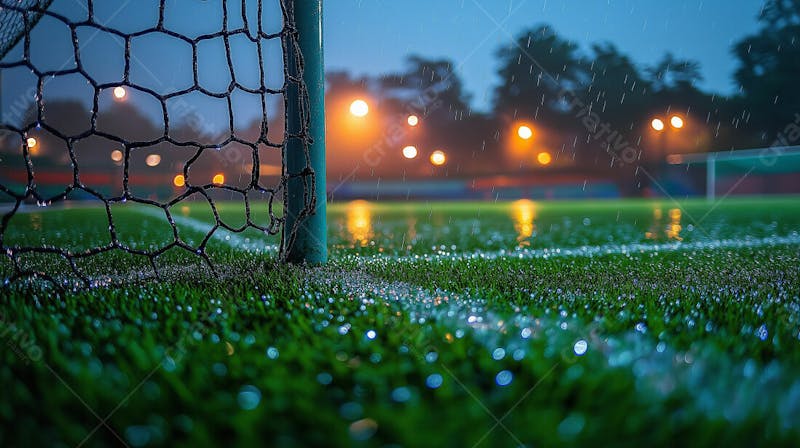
[2,0,761,128]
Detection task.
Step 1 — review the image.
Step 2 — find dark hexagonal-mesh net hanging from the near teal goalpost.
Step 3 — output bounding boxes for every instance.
[0,0,316,286]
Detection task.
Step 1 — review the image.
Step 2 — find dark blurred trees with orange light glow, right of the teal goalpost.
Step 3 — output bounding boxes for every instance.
[328,0,800,182]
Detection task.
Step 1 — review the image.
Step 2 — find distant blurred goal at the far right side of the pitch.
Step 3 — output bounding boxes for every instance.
[667,146,800,201]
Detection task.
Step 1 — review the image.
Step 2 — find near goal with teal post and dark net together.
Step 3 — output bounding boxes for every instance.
[0,0,327,285]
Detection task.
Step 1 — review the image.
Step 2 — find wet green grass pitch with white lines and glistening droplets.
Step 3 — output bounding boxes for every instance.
[0,198,800,447]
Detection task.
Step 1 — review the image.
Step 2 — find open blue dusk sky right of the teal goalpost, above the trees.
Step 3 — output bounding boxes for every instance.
[325,0,762,109]
